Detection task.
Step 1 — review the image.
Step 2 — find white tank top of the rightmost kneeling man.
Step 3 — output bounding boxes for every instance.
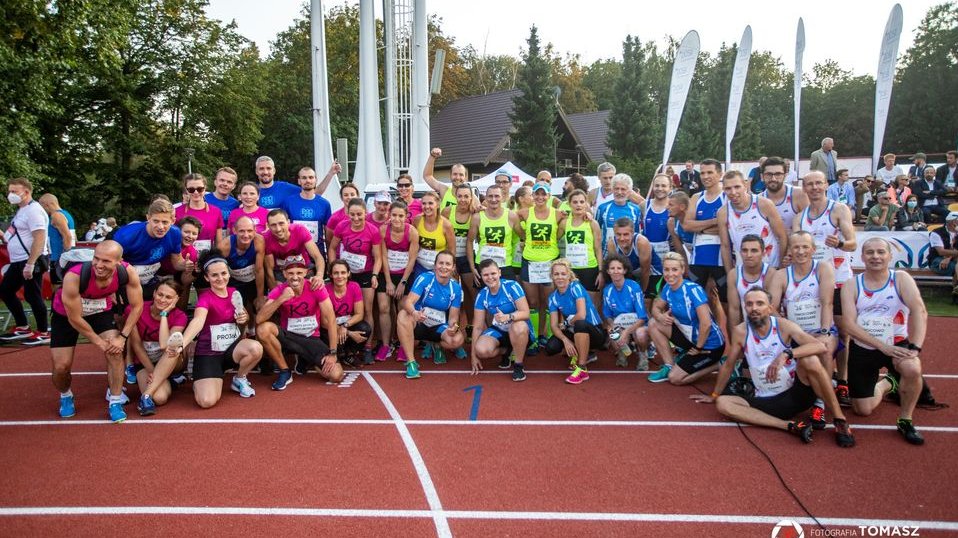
[855,271,910,349]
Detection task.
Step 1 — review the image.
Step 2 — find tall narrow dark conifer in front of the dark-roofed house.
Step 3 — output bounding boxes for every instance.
[509,25,558,170]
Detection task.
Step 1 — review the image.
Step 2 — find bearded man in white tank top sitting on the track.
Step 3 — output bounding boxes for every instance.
[690,286,855,448]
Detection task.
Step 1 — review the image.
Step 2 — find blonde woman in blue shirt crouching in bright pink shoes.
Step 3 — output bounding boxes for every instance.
[545,258,608,385]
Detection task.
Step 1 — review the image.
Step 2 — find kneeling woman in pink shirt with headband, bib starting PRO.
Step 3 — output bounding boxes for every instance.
[166,255,263,409]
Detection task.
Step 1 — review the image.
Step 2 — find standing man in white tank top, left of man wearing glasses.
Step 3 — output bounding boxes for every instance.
[716,170,787,272]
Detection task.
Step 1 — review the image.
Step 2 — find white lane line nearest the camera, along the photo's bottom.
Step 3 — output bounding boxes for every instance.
[0,506,958,531]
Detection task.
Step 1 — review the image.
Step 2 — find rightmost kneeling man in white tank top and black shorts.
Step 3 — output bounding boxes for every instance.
[842,237,928,445]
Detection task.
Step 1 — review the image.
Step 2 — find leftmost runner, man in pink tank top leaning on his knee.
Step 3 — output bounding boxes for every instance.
[50,240,143,422]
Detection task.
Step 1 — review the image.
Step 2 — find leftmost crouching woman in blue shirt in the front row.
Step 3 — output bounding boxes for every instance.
[398,250,466,379]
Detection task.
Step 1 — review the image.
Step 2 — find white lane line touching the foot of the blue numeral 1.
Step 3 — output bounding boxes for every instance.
[0,414,958,433]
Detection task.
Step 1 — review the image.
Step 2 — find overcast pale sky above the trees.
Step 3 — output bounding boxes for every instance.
[208,0,939,76]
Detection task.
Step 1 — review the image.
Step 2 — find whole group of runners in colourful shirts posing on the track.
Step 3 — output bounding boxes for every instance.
[10,149,927,447]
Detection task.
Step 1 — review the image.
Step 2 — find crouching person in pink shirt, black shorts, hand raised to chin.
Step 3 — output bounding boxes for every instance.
[256,256,344,390]
